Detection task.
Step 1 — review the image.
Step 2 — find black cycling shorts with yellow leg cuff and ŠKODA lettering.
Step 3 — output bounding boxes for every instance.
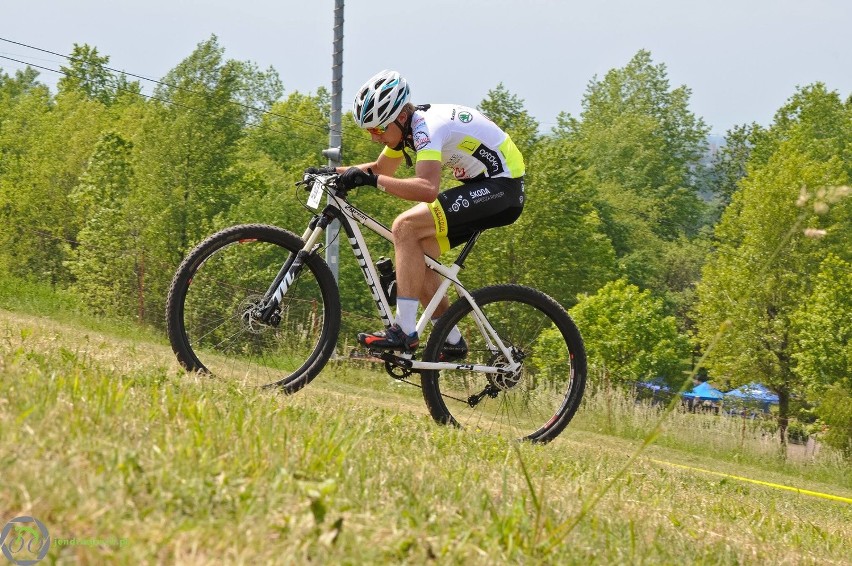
[429,177,524,253]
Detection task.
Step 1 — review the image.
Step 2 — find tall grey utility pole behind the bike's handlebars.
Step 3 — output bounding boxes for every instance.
[322,0,343,280]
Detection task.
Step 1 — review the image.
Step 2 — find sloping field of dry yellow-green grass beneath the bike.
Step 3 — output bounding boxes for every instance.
[0,310,852,564]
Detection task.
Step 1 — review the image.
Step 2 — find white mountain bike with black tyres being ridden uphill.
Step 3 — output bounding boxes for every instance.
[166,174,586,442]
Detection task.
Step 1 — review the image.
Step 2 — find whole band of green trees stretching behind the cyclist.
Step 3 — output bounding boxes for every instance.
[0,36,852,455]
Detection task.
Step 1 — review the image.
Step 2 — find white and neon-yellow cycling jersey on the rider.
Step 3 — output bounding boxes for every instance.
[384,104,524,181]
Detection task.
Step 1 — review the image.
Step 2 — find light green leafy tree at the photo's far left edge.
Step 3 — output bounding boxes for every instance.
[0,88,108,284]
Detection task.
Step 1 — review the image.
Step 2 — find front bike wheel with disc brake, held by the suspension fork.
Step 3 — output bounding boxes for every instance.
[166,224,340,393]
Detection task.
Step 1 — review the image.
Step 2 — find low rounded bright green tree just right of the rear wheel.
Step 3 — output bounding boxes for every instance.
[571,279,690,385]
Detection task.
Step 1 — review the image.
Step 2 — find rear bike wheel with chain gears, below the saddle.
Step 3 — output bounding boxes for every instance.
[421,285,586,442]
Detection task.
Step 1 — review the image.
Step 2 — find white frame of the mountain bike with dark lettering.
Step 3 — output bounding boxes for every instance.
[274,176,521,374]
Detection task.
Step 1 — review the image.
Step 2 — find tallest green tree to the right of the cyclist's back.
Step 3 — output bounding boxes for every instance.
[555,51,708,300]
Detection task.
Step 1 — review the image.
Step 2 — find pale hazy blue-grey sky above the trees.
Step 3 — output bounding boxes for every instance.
[0,0,852,135]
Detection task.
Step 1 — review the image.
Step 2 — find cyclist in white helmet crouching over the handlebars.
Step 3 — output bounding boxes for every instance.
[322,70,524,360]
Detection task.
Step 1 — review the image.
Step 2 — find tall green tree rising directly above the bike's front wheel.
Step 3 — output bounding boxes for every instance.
[140,36,279,248]
